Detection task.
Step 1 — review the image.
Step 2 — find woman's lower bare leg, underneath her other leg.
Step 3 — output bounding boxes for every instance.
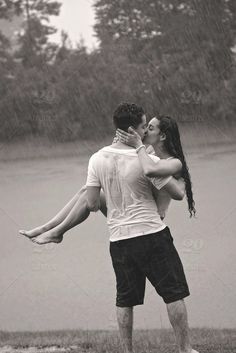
[31,187,107,245]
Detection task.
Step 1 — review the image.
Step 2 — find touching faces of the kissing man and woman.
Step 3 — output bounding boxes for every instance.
[135,115,164,145]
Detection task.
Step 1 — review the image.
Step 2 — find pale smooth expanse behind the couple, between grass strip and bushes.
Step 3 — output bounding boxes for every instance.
[0,140,236,331]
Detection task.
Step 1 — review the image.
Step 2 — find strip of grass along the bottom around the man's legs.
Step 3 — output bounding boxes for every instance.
[0,328,236,353]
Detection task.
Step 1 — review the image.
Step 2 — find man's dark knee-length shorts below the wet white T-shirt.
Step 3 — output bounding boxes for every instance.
[110,227,190,307]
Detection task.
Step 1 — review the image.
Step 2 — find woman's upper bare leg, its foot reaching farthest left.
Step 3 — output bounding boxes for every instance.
[19,186,86,238]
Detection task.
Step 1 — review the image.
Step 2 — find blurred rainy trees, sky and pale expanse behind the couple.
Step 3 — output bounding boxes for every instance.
[0,0,236,330]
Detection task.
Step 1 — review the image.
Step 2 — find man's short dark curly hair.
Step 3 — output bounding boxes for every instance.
[113,103,145,132]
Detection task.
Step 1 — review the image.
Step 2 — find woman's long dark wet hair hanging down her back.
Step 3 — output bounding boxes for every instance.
[157,115,196,217]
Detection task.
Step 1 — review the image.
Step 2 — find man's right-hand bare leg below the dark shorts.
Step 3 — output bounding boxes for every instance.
[166,299,192,353]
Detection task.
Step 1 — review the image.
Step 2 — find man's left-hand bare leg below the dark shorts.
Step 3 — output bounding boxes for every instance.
[116,306,133,353]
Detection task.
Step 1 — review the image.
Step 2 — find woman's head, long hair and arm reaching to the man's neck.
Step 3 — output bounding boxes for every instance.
[117,115,196,217]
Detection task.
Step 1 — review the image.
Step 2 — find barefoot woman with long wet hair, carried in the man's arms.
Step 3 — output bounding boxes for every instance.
[19,116,195,244]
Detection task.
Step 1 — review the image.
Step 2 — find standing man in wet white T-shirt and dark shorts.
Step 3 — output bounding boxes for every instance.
[86,103,196,353]
